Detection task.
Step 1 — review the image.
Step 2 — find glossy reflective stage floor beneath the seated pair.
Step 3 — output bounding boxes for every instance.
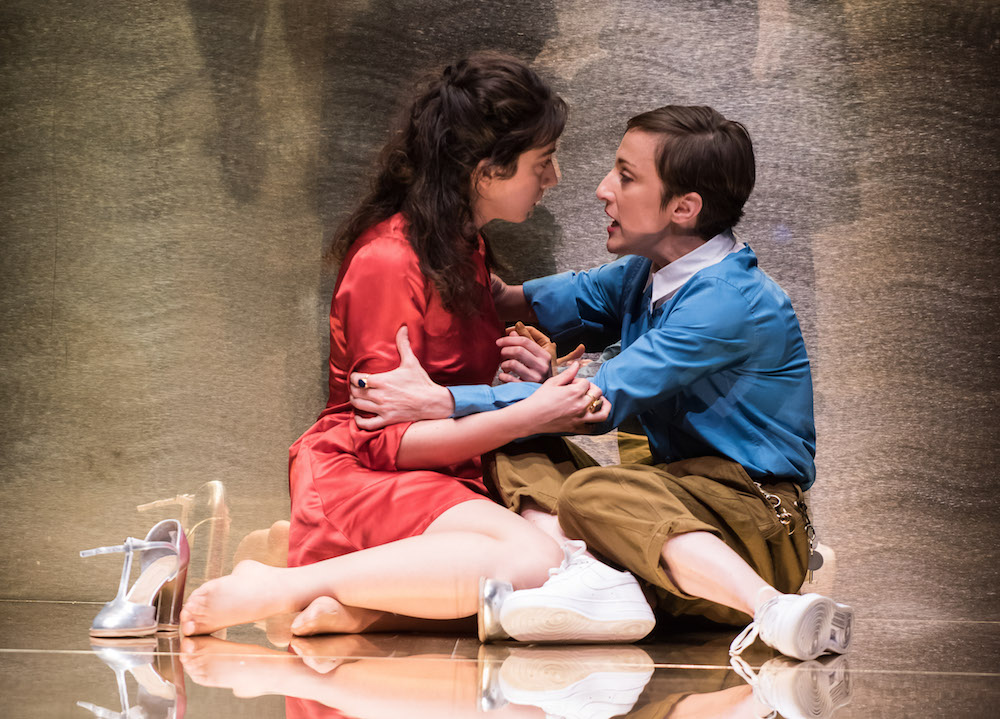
[0,602,1000,719]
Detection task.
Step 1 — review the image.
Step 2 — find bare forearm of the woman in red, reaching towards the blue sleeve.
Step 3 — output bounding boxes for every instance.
[396,403,534,469]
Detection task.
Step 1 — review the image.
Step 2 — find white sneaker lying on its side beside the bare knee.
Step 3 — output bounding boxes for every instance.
[499,541,656,643]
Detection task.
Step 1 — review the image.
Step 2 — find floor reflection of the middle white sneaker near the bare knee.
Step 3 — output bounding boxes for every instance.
[497,646,654,719]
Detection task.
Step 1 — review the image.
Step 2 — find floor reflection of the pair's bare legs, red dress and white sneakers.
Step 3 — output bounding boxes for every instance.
[181,634,850,719]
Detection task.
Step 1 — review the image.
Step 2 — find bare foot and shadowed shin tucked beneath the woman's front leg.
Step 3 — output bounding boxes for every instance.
[292,597,476,637]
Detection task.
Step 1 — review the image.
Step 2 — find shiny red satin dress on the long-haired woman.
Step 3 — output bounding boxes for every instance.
[288,214,502,566]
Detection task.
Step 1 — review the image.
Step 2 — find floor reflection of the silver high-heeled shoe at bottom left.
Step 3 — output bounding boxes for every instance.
[76,635,187,719]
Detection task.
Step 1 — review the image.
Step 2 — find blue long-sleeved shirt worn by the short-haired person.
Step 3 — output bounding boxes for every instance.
[449,247,816,489]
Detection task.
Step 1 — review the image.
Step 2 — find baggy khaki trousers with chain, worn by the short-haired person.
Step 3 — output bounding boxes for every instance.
[483,437,809,625]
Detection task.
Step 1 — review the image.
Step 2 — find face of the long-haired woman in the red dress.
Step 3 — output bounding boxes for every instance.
[472,142,561,227]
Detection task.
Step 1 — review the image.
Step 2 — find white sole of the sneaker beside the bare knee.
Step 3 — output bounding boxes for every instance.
[503,607,656,642]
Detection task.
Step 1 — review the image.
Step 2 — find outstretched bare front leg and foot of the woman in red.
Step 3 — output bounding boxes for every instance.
[181,500,561,634]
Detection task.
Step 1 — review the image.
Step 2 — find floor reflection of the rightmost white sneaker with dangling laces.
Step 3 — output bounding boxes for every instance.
[731,657,851,719]
